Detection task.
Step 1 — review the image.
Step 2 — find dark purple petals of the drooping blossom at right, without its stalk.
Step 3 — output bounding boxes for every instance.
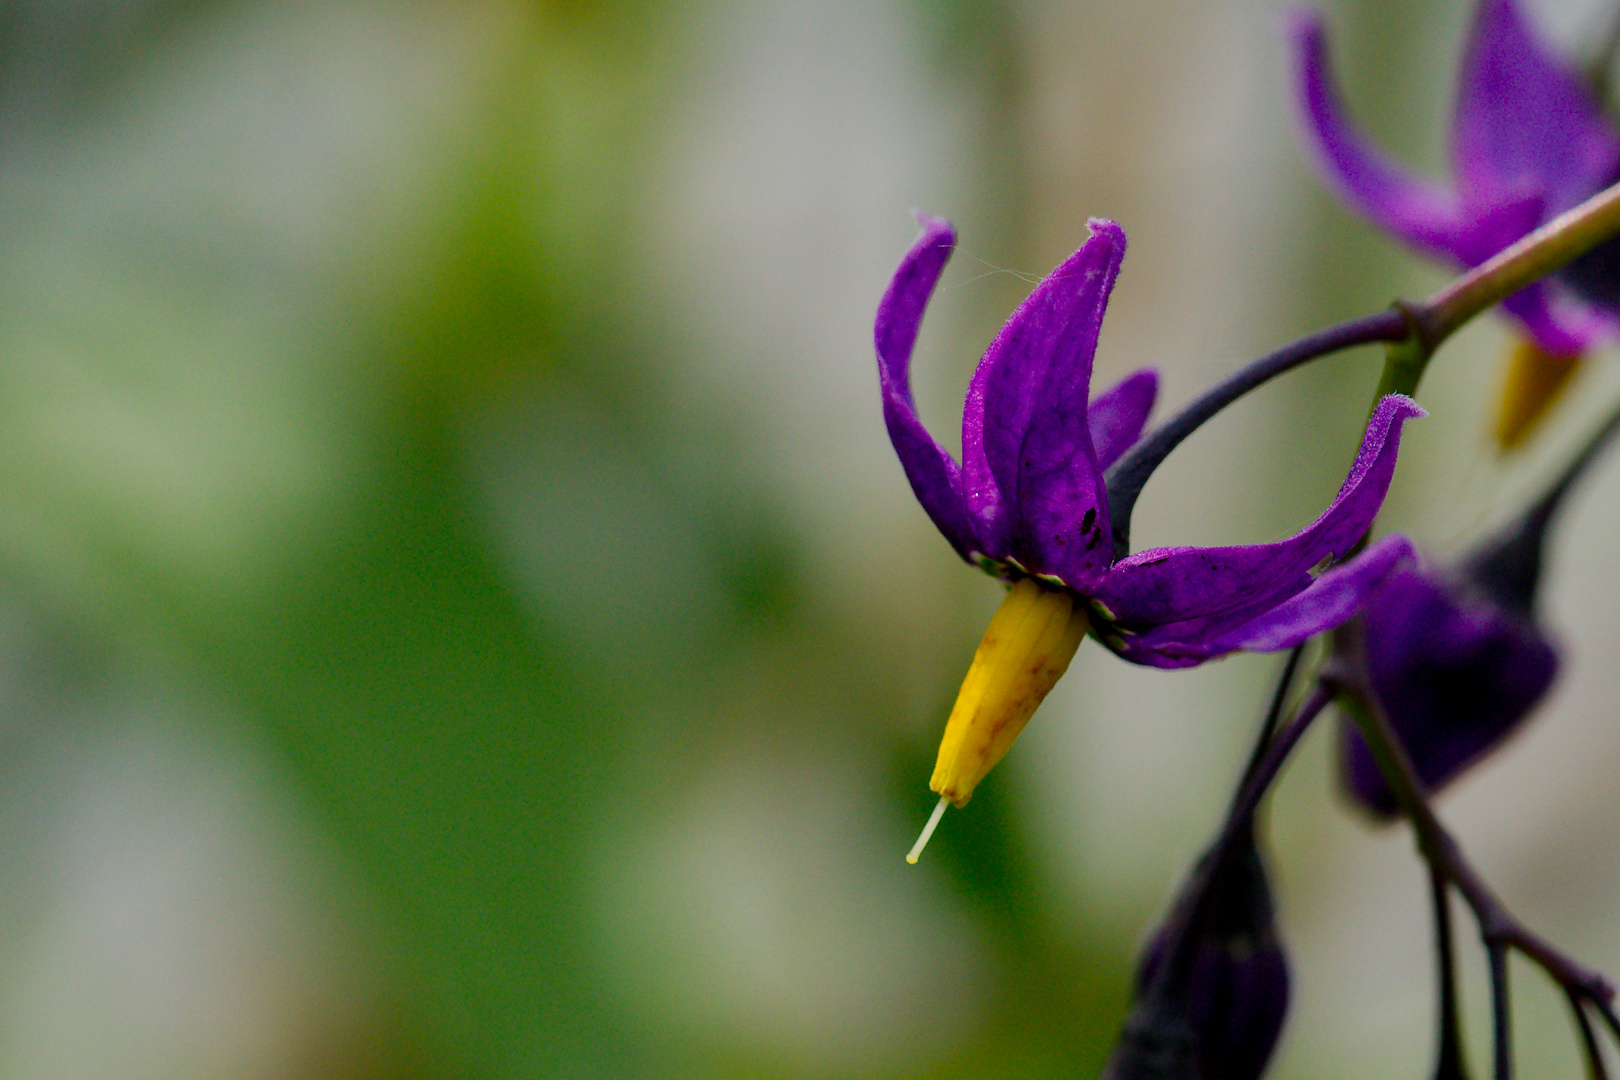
[1343,570,1558,814]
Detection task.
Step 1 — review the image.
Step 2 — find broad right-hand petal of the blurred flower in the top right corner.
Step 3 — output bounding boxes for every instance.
[1452,0,1620,217]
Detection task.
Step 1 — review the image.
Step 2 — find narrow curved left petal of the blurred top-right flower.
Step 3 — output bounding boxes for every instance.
[1288,11,1466,257]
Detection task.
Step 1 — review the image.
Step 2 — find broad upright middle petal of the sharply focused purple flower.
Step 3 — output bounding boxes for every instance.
[962,219,1124,589]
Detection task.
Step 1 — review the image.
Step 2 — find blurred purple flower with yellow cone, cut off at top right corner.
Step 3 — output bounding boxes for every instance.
[1290,0,1620,449]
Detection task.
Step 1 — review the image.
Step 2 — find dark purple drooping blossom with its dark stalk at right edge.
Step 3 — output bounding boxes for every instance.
[1341,393,1620,816]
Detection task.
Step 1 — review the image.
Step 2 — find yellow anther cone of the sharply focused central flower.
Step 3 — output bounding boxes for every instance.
[928,578,1089,806]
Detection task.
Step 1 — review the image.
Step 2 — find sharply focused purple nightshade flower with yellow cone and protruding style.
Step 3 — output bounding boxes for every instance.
[875,217,1422,857]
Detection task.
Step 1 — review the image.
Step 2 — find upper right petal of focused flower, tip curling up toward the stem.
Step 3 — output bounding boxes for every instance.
[1092,393,1426,667]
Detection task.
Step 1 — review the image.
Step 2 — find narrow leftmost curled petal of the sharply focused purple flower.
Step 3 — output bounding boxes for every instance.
[873,215,978,562]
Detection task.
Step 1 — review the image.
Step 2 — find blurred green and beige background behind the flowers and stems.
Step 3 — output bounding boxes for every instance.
[9,0,1620,1080]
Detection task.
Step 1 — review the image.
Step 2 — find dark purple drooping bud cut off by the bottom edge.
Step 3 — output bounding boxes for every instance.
[1103,827,1288,1080]
